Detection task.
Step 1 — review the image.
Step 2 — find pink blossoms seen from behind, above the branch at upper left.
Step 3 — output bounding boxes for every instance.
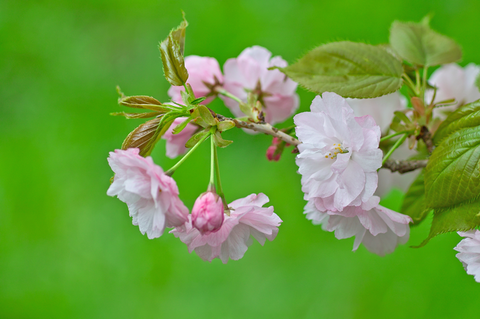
[163,46,300,158]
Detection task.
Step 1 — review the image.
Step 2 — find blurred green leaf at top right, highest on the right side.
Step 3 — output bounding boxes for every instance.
[390,19,462,67]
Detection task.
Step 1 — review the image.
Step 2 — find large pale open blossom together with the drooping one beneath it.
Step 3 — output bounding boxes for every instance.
[294,92,411,255]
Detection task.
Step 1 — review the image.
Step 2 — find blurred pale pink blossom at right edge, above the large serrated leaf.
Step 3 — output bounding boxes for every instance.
[425,63,480,111]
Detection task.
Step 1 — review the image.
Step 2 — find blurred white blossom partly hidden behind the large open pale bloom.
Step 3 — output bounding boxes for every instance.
[347,91,418,196]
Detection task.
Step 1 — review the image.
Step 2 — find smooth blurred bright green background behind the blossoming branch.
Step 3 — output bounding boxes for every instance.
[0,0,480,318]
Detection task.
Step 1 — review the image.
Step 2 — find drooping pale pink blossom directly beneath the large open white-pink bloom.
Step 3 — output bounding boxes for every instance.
[305,196,412,256]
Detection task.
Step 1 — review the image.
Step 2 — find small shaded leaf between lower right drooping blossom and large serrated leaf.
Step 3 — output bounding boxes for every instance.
[400,170,430,225]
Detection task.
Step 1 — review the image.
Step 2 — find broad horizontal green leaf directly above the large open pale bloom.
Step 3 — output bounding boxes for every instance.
[280,41,403,98]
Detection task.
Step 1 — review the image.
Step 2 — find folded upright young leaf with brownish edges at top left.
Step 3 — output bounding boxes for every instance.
[159,20,188,86]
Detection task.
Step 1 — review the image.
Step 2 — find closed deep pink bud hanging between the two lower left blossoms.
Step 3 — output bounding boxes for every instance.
[192,192,224,234]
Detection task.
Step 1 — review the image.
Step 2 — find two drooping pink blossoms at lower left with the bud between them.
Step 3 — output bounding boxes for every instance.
[107,148,282,263]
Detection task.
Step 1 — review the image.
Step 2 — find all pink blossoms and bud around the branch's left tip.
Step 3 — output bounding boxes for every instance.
[107,46,299,263]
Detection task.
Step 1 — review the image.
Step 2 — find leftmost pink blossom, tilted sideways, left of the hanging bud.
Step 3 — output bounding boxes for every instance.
[107,148,189,239]
